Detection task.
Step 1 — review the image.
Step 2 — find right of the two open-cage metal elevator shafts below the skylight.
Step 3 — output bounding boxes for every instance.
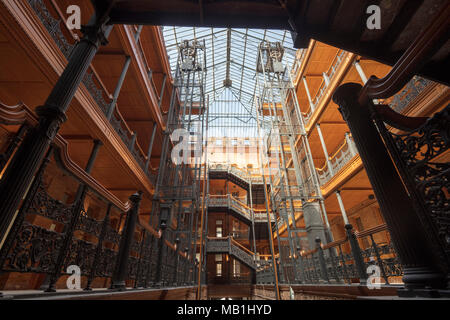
[255,42,325,283]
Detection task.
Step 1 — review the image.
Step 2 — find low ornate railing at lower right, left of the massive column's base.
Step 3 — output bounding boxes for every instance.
[256,224,403,285]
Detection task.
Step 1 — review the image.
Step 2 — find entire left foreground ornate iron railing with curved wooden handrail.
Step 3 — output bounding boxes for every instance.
[0,104,186,289]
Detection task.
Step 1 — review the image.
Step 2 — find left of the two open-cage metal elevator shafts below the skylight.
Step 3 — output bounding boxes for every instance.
[150,40,207,284]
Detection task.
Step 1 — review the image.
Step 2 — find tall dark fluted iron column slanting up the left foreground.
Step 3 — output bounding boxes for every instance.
[0,13,112,244]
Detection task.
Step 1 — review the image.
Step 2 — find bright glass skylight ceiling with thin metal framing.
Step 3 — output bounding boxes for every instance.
[163,26,296,137]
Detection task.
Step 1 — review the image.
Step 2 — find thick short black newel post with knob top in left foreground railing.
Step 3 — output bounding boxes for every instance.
[111,191,142,291]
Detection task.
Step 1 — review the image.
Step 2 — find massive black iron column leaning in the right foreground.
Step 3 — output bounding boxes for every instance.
[333,83,445,294]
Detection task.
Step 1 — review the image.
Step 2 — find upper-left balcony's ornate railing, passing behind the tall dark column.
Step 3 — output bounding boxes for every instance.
[28,0,154,181]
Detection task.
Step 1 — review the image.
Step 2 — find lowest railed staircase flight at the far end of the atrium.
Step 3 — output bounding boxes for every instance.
[206,237,256,270]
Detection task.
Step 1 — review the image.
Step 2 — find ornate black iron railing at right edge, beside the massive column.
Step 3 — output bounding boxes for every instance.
[372,105,450,272]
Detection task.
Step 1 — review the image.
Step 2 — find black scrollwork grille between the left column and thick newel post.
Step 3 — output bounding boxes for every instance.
[0,146,121,284]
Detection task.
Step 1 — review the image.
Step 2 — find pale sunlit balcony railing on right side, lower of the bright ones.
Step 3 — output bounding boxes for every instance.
[317,134,358,185]
